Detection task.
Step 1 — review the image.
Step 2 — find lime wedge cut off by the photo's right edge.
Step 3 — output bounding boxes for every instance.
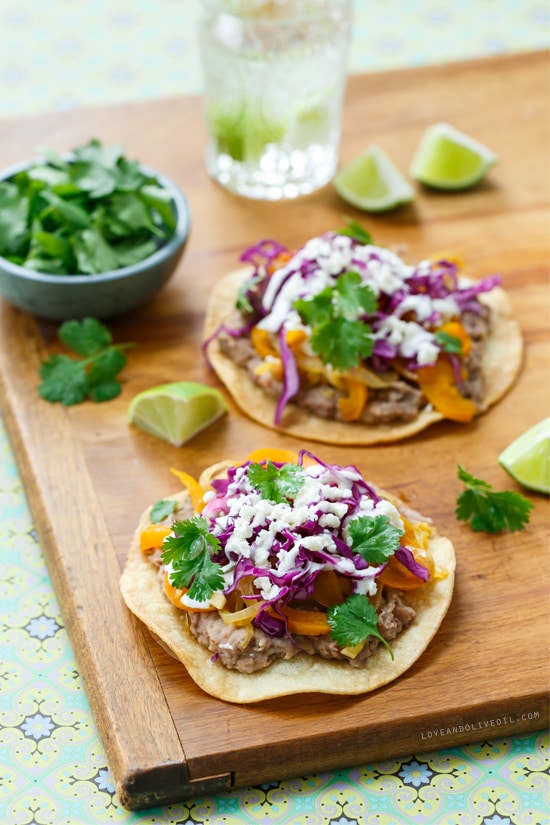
[498,418,550,493]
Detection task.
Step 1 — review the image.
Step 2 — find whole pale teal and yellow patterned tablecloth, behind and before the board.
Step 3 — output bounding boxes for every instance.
[0,0,550,825]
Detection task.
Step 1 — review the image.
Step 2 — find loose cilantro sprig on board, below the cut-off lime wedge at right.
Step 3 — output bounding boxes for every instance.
[455,464,534,533]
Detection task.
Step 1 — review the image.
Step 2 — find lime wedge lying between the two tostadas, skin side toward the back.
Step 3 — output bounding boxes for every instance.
[128,381,227,447]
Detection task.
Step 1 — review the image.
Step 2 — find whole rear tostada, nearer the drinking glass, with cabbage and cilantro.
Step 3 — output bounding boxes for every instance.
[204,226,522,445]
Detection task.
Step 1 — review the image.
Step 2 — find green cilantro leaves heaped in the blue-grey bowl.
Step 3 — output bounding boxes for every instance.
[0,140,177,276]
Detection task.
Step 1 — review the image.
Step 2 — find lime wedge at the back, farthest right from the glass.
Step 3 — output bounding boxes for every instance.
[410,123,498,189]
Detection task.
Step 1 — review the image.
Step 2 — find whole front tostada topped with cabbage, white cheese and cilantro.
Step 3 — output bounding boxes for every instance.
[121,450,455,703]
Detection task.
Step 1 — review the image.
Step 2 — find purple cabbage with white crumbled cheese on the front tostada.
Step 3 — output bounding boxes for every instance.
[202,449,429,635]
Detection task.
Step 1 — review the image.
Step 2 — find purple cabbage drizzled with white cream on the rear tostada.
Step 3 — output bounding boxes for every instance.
[203,232,500,425]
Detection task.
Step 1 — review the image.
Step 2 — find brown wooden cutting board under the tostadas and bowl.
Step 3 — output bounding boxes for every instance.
[0,54,550,808]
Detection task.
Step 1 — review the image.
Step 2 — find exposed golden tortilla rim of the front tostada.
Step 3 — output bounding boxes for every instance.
[120,491,455,704]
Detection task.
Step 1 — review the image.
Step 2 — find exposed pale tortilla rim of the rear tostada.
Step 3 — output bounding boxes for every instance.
[204,267,523,446]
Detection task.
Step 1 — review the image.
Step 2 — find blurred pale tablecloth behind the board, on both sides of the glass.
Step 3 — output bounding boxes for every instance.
[0,0,550,117]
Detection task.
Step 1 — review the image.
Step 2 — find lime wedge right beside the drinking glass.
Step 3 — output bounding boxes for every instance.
[333,146,414,212]
